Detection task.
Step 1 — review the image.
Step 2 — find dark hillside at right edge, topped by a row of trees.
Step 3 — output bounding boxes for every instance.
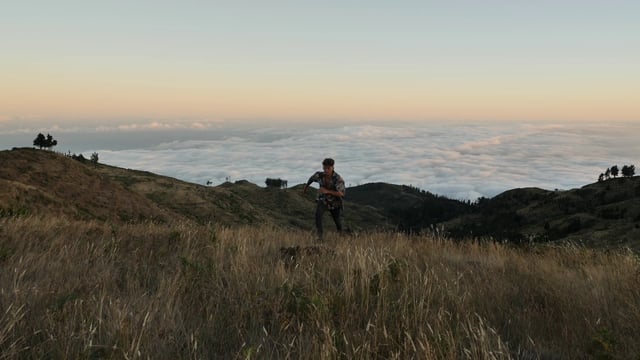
[446,176,640,250]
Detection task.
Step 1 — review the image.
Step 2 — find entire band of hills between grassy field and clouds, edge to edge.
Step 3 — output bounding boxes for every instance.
[0,148,640,249]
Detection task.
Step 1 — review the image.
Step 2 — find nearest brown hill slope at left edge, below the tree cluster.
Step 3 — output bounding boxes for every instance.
[0,149,179,221]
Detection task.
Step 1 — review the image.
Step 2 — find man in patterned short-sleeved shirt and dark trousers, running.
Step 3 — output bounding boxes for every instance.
[303,158,345,240]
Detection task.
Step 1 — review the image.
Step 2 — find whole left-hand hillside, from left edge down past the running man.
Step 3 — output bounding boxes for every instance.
[0,148,392,230]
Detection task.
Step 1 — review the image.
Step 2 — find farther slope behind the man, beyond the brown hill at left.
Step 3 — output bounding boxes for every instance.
[92,160,390,230]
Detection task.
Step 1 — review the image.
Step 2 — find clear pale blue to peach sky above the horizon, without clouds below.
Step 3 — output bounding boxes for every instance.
[0,0,640,125]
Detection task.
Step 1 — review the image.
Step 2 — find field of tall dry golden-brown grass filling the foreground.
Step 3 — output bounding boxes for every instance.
[0,217,640,359]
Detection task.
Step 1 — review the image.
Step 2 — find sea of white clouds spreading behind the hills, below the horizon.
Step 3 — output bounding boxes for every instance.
[86,123,640,199]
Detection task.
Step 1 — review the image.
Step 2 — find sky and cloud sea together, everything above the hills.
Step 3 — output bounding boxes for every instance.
[0,0,640,200]
